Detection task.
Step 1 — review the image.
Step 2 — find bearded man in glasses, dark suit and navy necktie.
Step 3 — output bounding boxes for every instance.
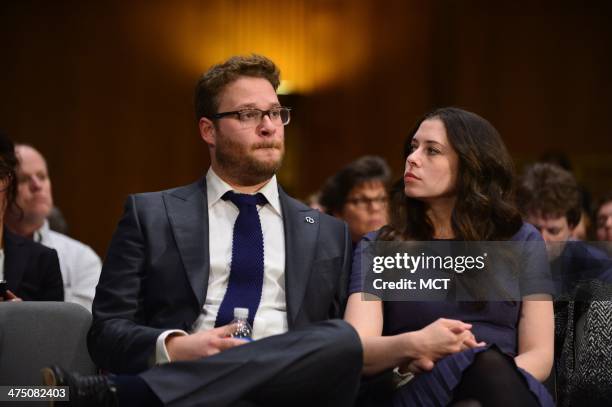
[46,55,362,406]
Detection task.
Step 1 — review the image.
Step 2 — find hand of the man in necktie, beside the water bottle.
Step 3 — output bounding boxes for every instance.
[166,325,246,362]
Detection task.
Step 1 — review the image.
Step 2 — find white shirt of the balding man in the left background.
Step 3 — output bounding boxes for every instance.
[34,221,102,312]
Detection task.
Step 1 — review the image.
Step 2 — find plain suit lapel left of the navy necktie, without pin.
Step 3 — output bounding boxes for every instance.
[164,179,210,306]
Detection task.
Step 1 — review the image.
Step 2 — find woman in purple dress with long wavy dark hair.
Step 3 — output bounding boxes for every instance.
[345,108,554,406]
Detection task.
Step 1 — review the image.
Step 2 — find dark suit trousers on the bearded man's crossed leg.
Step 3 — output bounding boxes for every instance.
[140,320,363,407]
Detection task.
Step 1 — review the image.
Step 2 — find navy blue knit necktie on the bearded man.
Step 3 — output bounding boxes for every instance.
[215,191,267,327]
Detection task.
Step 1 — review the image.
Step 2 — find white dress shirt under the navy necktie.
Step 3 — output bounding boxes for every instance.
[155,168,288,364]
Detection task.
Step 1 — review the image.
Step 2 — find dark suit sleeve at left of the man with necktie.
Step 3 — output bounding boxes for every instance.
[87,196,164,373]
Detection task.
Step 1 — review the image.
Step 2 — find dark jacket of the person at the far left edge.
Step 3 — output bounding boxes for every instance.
[4,228,64,301]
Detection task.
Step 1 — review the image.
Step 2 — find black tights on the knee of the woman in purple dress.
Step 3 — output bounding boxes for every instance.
[451,349,539,407]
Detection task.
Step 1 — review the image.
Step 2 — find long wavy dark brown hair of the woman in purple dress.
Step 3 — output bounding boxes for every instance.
[379,107,522,241]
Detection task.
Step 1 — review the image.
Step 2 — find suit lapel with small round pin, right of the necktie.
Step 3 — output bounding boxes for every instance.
[278,187,319,329]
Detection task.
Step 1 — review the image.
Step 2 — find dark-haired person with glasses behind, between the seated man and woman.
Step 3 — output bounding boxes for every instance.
[319,156,390,244]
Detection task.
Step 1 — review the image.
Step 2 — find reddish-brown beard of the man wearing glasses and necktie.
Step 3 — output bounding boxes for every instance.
[215,138,285,186]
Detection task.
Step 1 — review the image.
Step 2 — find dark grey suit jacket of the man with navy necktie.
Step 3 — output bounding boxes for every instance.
[88,179,352,373]
